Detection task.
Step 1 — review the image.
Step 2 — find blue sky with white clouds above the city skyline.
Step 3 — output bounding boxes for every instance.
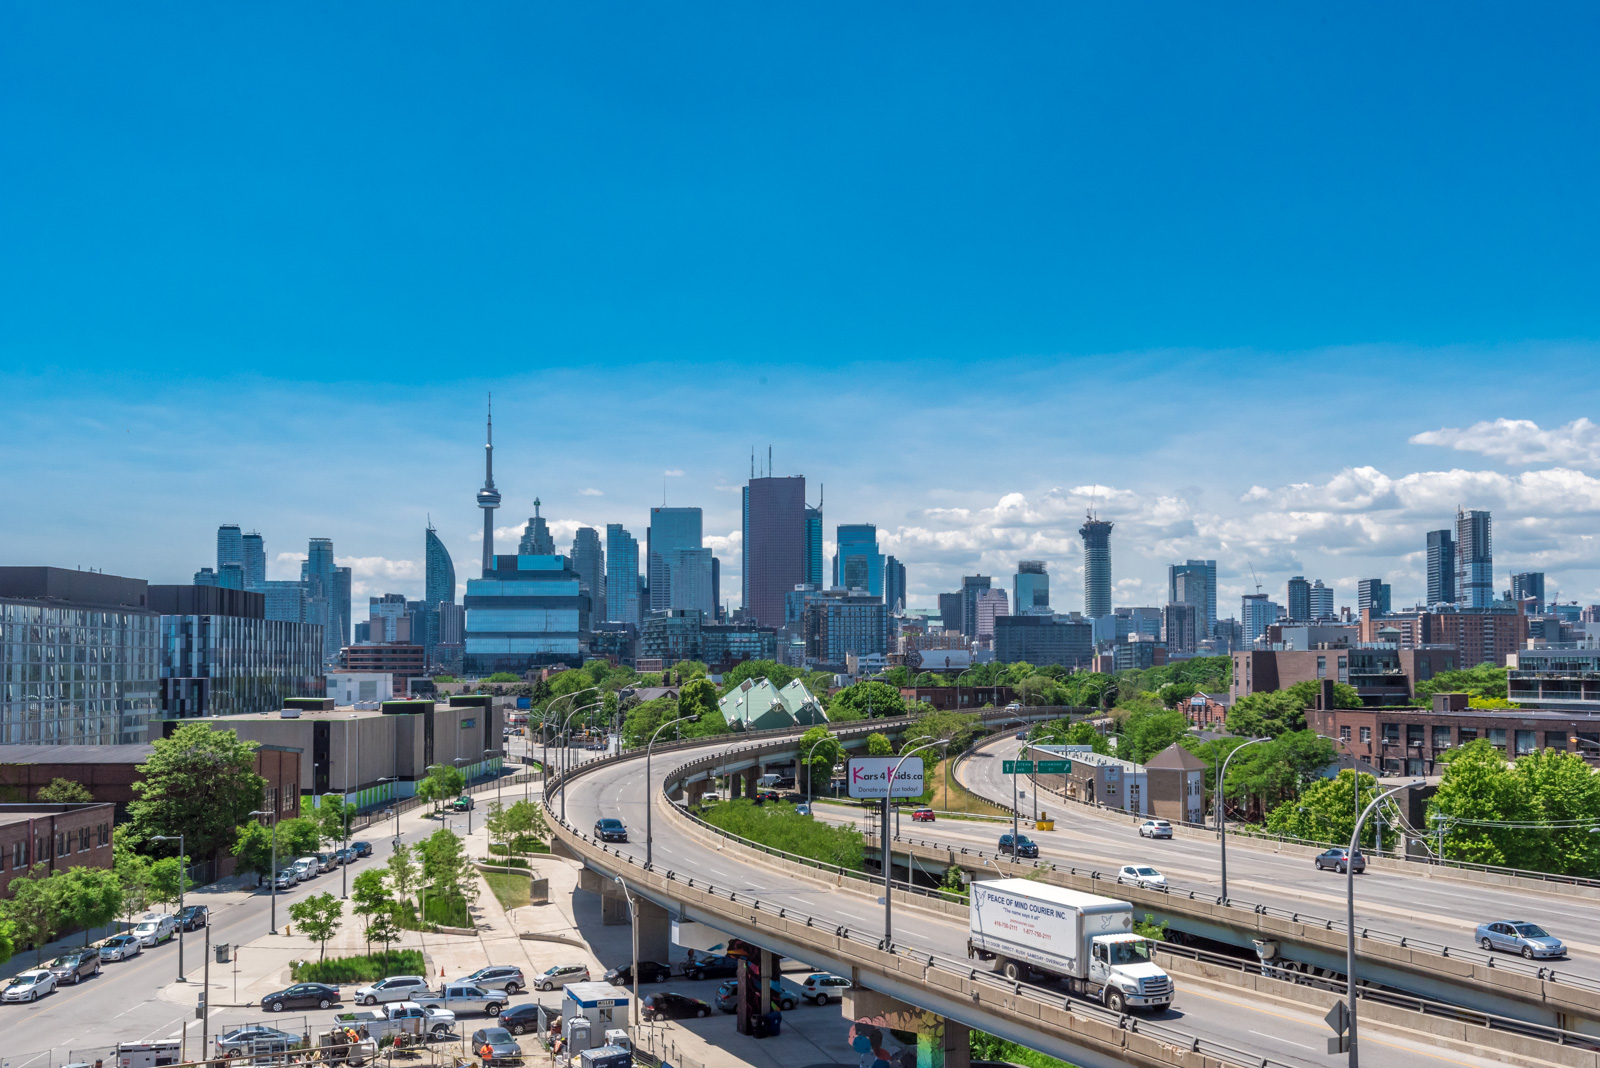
[0,3,1600,617]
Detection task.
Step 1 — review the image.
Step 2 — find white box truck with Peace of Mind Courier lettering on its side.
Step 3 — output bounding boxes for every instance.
[966,879,1173,1012]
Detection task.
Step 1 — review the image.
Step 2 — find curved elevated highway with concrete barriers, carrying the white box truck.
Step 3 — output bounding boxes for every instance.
[550,721,1587,1068]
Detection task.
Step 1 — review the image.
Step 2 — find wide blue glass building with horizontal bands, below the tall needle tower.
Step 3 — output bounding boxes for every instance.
[464,555,589,675]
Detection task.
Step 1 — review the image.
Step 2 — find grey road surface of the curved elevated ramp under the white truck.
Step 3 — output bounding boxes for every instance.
[566,735,1523,1068]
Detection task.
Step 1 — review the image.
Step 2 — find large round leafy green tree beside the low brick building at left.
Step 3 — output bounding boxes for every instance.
[123,723,266,860]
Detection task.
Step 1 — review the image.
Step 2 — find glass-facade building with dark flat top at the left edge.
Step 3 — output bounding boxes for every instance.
[0,568,160,745]
